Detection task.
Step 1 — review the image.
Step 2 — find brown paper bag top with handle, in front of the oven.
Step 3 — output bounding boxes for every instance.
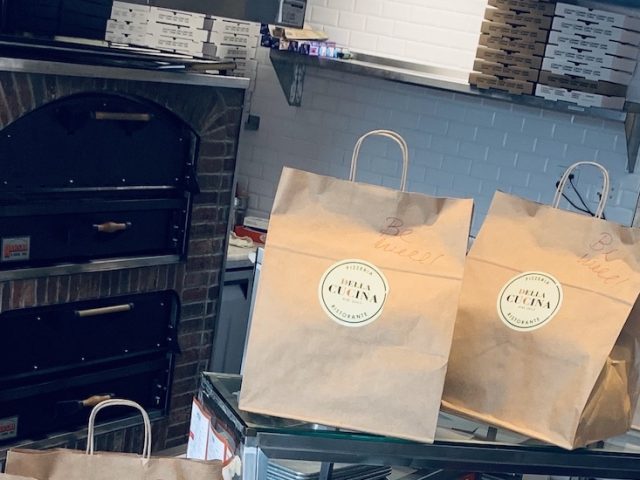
[5,399,222,480]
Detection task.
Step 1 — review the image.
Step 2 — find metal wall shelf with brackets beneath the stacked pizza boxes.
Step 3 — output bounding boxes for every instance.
[269,50,640,172]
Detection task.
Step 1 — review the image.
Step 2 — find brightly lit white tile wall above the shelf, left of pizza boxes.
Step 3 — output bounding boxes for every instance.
[307,0,487,71]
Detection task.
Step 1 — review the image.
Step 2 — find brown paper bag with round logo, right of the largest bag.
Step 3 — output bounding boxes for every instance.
[443,162,640,449]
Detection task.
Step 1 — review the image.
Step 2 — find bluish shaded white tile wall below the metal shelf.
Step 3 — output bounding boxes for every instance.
[238,49,640,233]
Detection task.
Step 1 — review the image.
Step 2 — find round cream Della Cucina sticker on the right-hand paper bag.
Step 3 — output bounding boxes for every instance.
[498,272,562,332]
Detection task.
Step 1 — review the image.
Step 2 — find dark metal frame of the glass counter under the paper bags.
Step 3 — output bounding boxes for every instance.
[200,373,640,480]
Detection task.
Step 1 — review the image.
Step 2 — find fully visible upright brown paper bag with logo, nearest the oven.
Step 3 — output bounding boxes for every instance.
[240,131,473,442]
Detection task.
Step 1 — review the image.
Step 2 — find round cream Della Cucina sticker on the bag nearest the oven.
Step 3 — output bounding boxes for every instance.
[318,260,389,327]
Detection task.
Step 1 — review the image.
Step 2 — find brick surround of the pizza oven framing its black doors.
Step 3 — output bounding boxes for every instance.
[0,51,246,458]
